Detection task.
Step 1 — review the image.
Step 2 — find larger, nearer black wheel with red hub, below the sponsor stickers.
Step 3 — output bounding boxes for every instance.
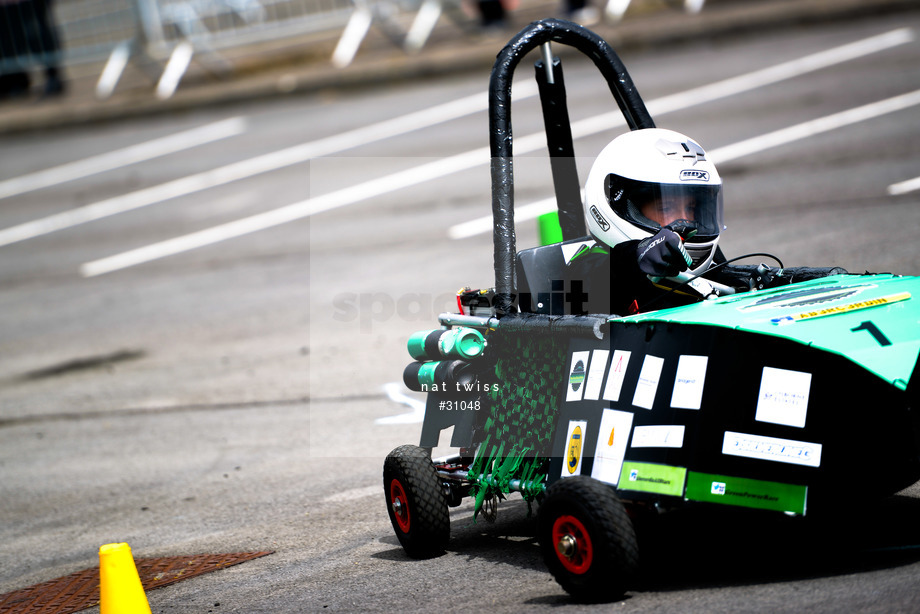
[537,476,639,602]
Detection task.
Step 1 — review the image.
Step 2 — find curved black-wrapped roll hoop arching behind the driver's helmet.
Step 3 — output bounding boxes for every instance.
[489,19,655,316]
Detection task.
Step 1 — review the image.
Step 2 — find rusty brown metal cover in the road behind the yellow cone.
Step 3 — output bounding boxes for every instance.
[0,552,271,614]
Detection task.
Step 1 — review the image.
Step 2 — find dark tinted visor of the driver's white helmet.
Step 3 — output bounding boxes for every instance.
[607,174,722,241]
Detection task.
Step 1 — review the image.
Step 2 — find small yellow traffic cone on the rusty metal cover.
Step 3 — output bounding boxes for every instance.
[99,544,150,614]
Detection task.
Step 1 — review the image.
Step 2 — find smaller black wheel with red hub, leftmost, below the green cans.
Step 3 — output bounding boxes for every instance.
[383,445,450,559]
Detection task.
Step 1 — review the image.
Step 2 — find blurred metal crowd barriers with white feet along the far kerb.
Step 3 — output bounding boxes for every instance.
[0,0,705,98]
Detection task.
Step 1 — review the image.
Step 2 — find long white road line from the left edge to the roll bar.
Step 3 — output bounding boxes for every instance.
[0,84,537,246]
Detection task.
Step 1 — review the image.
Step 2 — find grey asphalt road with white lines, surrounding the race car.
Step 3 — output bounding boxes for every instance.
[0,6,920,612]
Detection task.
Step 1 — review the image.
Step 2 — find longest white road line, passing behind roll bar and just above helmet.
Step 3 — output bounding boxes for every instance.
[80,28,914,277]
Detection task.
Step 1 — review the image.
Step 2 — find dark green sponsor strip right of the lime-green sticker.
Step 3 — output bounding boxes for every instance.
[685,471,808,515]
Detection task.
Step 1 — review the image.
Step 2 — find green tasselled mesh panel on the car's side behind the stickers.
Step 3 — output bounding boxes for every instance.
[470,329,566,517]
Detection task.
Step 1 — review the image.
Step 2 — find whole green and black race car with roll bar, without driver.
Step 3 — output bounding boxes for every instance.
[383,20,920,600]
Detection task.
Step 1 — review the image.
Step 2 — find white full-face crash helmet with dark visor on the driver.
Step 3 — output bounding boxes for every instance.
[584,128,724,273]
